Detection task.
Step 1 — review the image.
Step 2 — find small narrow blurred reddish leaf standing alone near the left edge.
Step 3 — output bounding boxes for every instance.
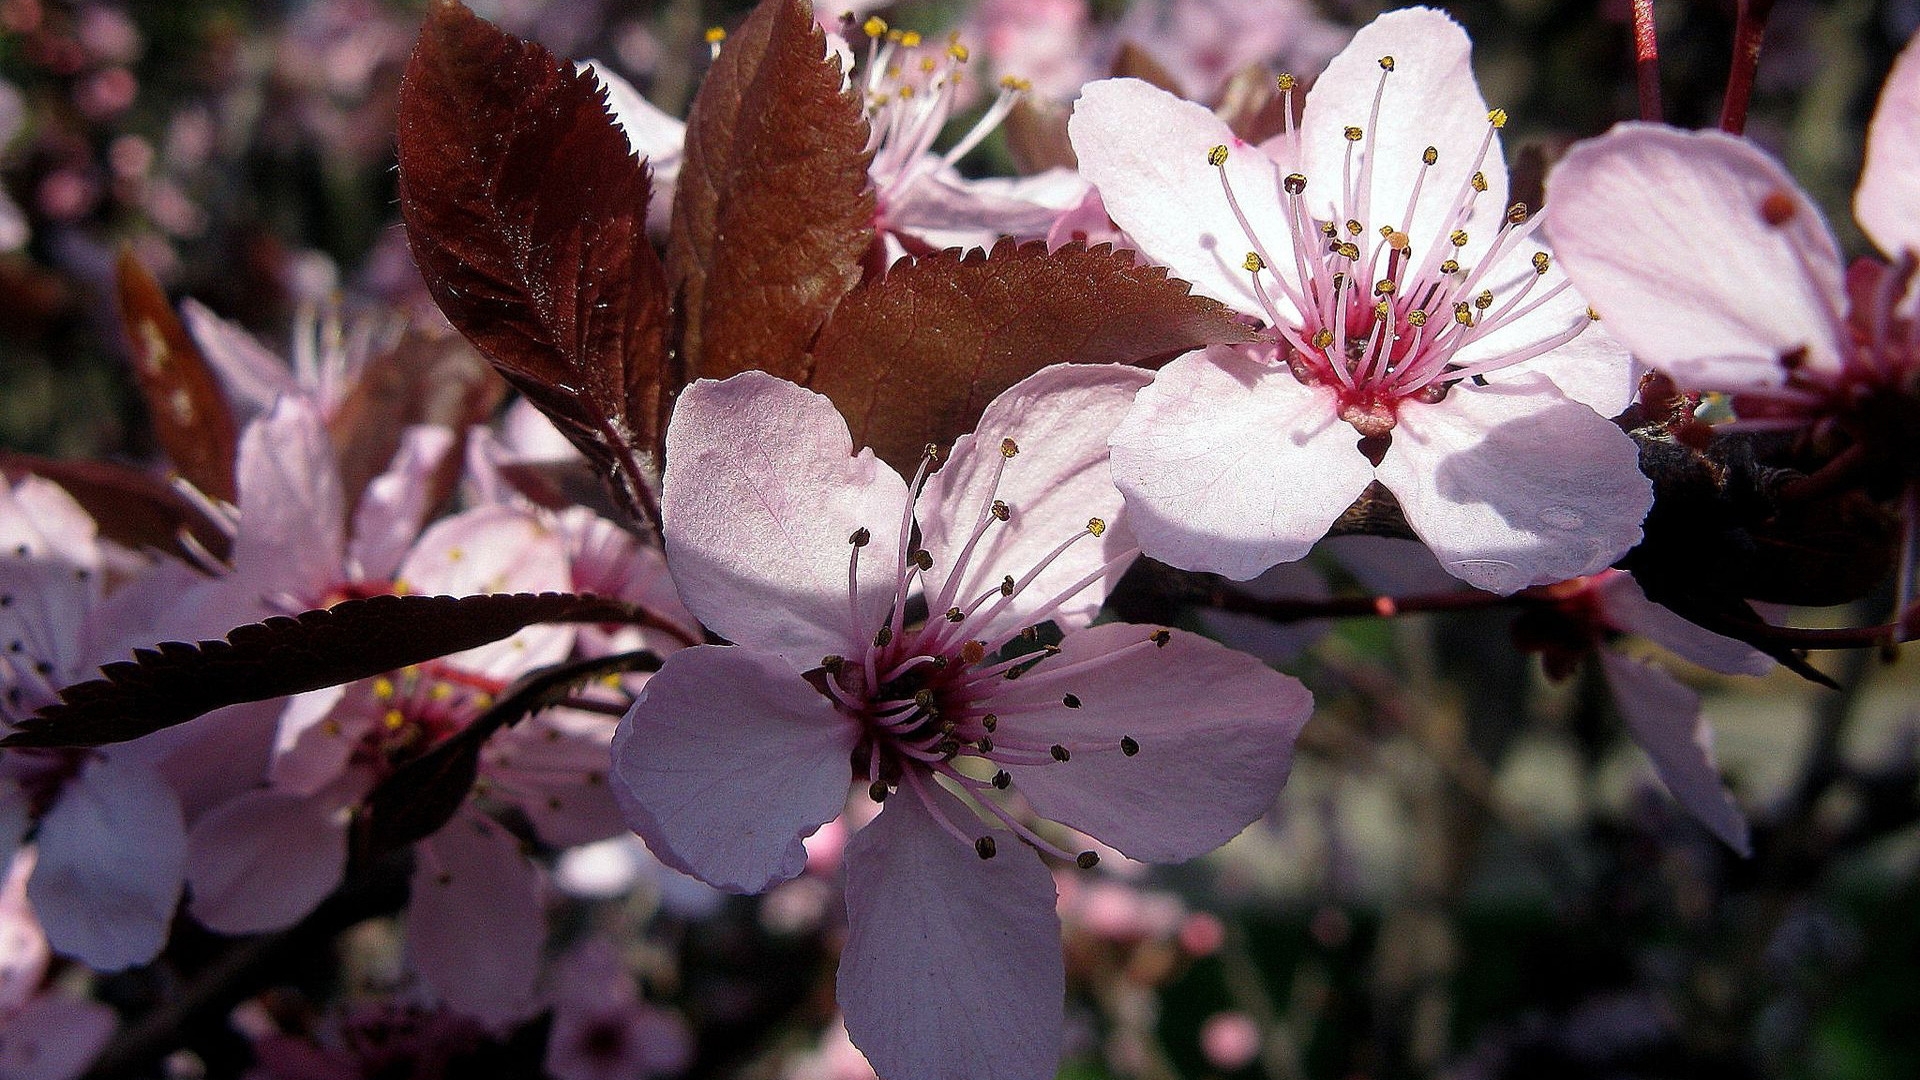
[113,248,240,502]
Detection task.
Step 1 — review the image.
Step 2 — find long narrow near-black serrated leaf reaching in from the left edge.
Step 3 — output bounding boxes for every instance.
[0,592,643,746]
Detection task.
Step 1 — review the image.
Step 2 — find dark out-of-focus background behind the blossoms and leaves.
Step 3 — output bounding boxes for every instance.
[0,0,1920,1080]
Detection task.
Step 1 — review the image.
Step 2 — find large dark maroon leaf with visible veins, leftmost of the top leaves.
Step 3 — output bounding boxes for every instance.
[397,0,678,513]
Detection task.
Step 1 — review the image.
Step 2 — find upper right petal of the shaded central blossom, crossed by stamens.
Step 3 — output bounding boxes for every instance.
[918,365,1152,640]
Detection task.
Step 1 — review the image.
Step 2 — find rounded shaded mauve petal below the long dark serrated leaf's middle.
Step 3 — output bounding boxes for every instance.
[186,790,348,934]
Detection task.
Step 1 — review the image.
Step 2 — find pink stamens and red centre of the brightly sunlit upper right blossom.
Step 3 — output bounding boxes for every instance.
[1208,56,1594,438]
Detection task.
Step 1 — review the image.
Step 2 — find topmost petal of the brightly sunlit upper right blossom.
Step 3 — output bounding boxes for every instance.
[1297,8,1507,265]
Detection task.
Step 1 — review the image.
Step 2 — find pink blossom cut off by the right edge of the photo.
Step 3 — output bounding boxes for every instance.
[1548,29,1920,611]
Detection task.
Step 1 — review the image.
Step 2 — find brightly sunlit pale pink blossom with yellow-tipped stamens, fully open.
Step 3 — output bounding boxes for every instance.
[1069,8,1651,592]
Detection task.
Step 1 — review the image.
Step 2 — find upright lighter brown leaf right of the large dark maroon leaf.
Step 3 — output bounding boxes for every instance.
[666,0,874,379]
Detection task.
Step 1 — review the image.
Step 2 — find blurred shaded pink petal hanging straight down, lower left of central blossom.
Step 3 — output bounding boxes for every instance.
[407,809,547,1026]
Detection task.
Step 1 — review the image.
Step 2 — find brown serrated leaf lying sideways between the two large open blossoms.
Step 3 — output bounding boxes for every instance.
[808,240,1252,469]
